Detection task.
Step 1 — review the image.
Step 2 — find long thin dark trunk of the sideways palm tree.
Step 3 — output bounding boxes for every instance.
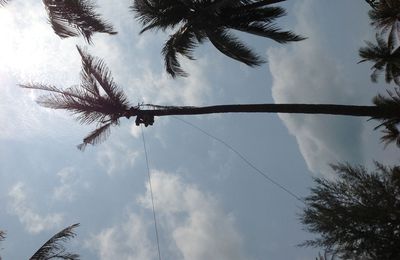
[126,104,399,118]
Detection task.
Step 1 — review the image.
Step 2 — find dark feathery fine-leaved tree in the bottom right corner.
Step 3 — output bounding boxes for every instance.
[300,163,400,260]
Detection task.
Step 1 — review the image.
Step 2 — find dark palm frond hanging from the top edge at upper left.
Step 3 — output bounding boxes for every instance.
[43,0,116,43]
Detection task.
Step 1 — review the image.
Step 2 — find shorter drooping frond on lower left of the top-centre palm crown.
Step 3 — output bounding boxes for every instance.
[162,26,196,78]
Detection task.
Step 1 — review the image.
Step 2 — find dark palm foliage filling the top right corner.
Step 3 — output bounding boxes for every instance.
[368,0,400,50]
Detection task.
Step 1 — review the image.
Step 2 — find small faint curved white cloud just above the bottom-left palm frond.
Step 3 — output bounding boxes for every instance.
[8,182,63,234]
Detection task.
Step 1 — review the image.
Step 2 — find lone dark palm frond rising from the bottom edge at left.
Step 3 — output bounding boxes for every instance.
[30,224,79,260]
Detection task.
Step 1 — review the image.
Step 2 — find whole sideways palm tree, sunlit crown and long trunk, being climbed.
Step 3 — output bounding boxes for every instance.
[21,47,400,149]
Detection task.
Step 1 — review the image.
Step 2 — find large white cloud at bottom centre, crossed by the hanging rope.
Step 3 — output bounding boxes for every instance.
[87,171,249,260]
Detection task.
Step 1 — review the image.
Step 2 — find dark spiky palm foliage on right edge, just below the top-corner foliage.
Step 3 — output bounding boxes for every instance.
[359,34,400,86]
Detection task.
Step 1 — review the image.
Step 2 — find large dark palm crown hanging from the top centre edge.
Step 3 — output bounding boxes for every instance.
[131,0,304,77]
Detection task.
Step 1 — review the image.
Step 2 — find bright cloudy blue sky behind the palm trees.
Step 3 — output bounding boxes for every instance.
[0,0,398,260]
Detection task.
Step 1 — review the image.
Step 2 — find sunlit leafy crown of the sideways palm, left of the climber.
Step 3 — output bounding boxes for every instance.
[21,47,130,149]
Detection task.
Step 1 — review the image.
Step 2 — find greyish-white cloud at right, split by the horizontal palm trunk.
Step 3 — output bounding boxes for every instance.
[268,1,368,174]
